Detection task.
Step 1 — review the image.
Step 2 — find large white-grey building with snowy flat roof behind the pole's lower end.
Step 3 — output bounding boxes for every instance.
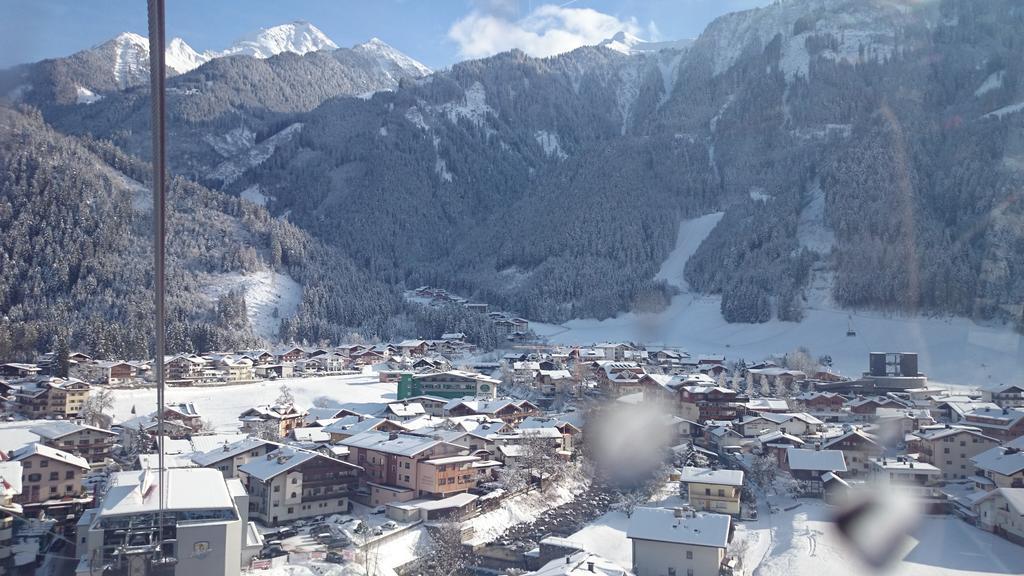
[76,468,262,576]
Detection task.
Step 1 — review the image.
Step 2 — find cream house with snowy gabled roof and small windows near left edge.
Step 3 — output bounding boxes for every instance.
[10,443,90,513]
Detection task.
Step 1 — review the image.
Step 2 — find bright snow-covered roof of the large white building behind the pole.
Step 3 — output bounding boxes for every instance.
[99,468,234,518]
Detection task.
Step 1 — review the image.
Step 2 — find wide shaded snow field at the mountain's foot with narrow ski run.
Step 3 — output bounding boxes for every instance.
[530,214,1024,386]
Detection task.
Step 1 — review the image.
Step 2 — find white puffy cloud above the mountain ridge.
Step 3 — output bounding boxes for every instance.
[449,4,638,58]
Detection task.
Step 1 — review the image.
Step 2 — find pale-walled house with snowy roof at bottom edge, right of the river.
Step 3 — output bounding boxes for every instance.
[626,507,731,576]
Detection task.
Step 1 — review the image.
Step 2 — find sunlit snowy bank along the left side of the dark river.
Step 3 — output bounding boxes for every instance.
[467,477,585,545]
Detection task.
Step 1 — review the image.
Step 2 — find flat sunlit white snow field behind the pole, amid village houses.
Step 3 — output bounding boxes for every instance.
[103,373,396,433]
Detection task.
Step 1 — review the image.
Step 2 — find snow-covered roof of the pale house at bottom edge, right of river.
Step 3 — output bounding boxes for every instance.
[626,508,730,548]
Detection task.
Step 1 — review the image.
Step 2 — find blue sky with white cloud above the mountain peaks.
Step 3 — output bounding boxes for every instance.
[0,0,769,68]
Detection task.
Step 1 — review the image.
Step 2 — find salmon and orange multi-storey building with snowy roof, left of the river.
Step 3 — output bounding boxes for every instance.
[341,431,480,506]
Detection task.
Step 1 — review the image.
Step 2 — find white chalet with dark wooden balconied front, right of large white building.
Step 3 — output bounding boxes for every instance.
[239,446,361,526]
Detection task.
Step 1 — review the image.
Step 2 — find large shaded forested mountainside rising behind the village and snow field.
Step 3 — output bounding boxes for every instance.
[6,0,1024,350]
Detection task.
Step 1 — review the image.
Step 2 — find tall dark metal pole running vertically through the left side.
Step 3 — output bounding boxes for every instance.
[148,0,167,557]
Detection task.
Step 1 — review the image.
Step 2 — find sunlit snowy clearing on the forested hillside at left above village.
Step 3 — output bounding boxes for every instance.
[203,271,302,340]
